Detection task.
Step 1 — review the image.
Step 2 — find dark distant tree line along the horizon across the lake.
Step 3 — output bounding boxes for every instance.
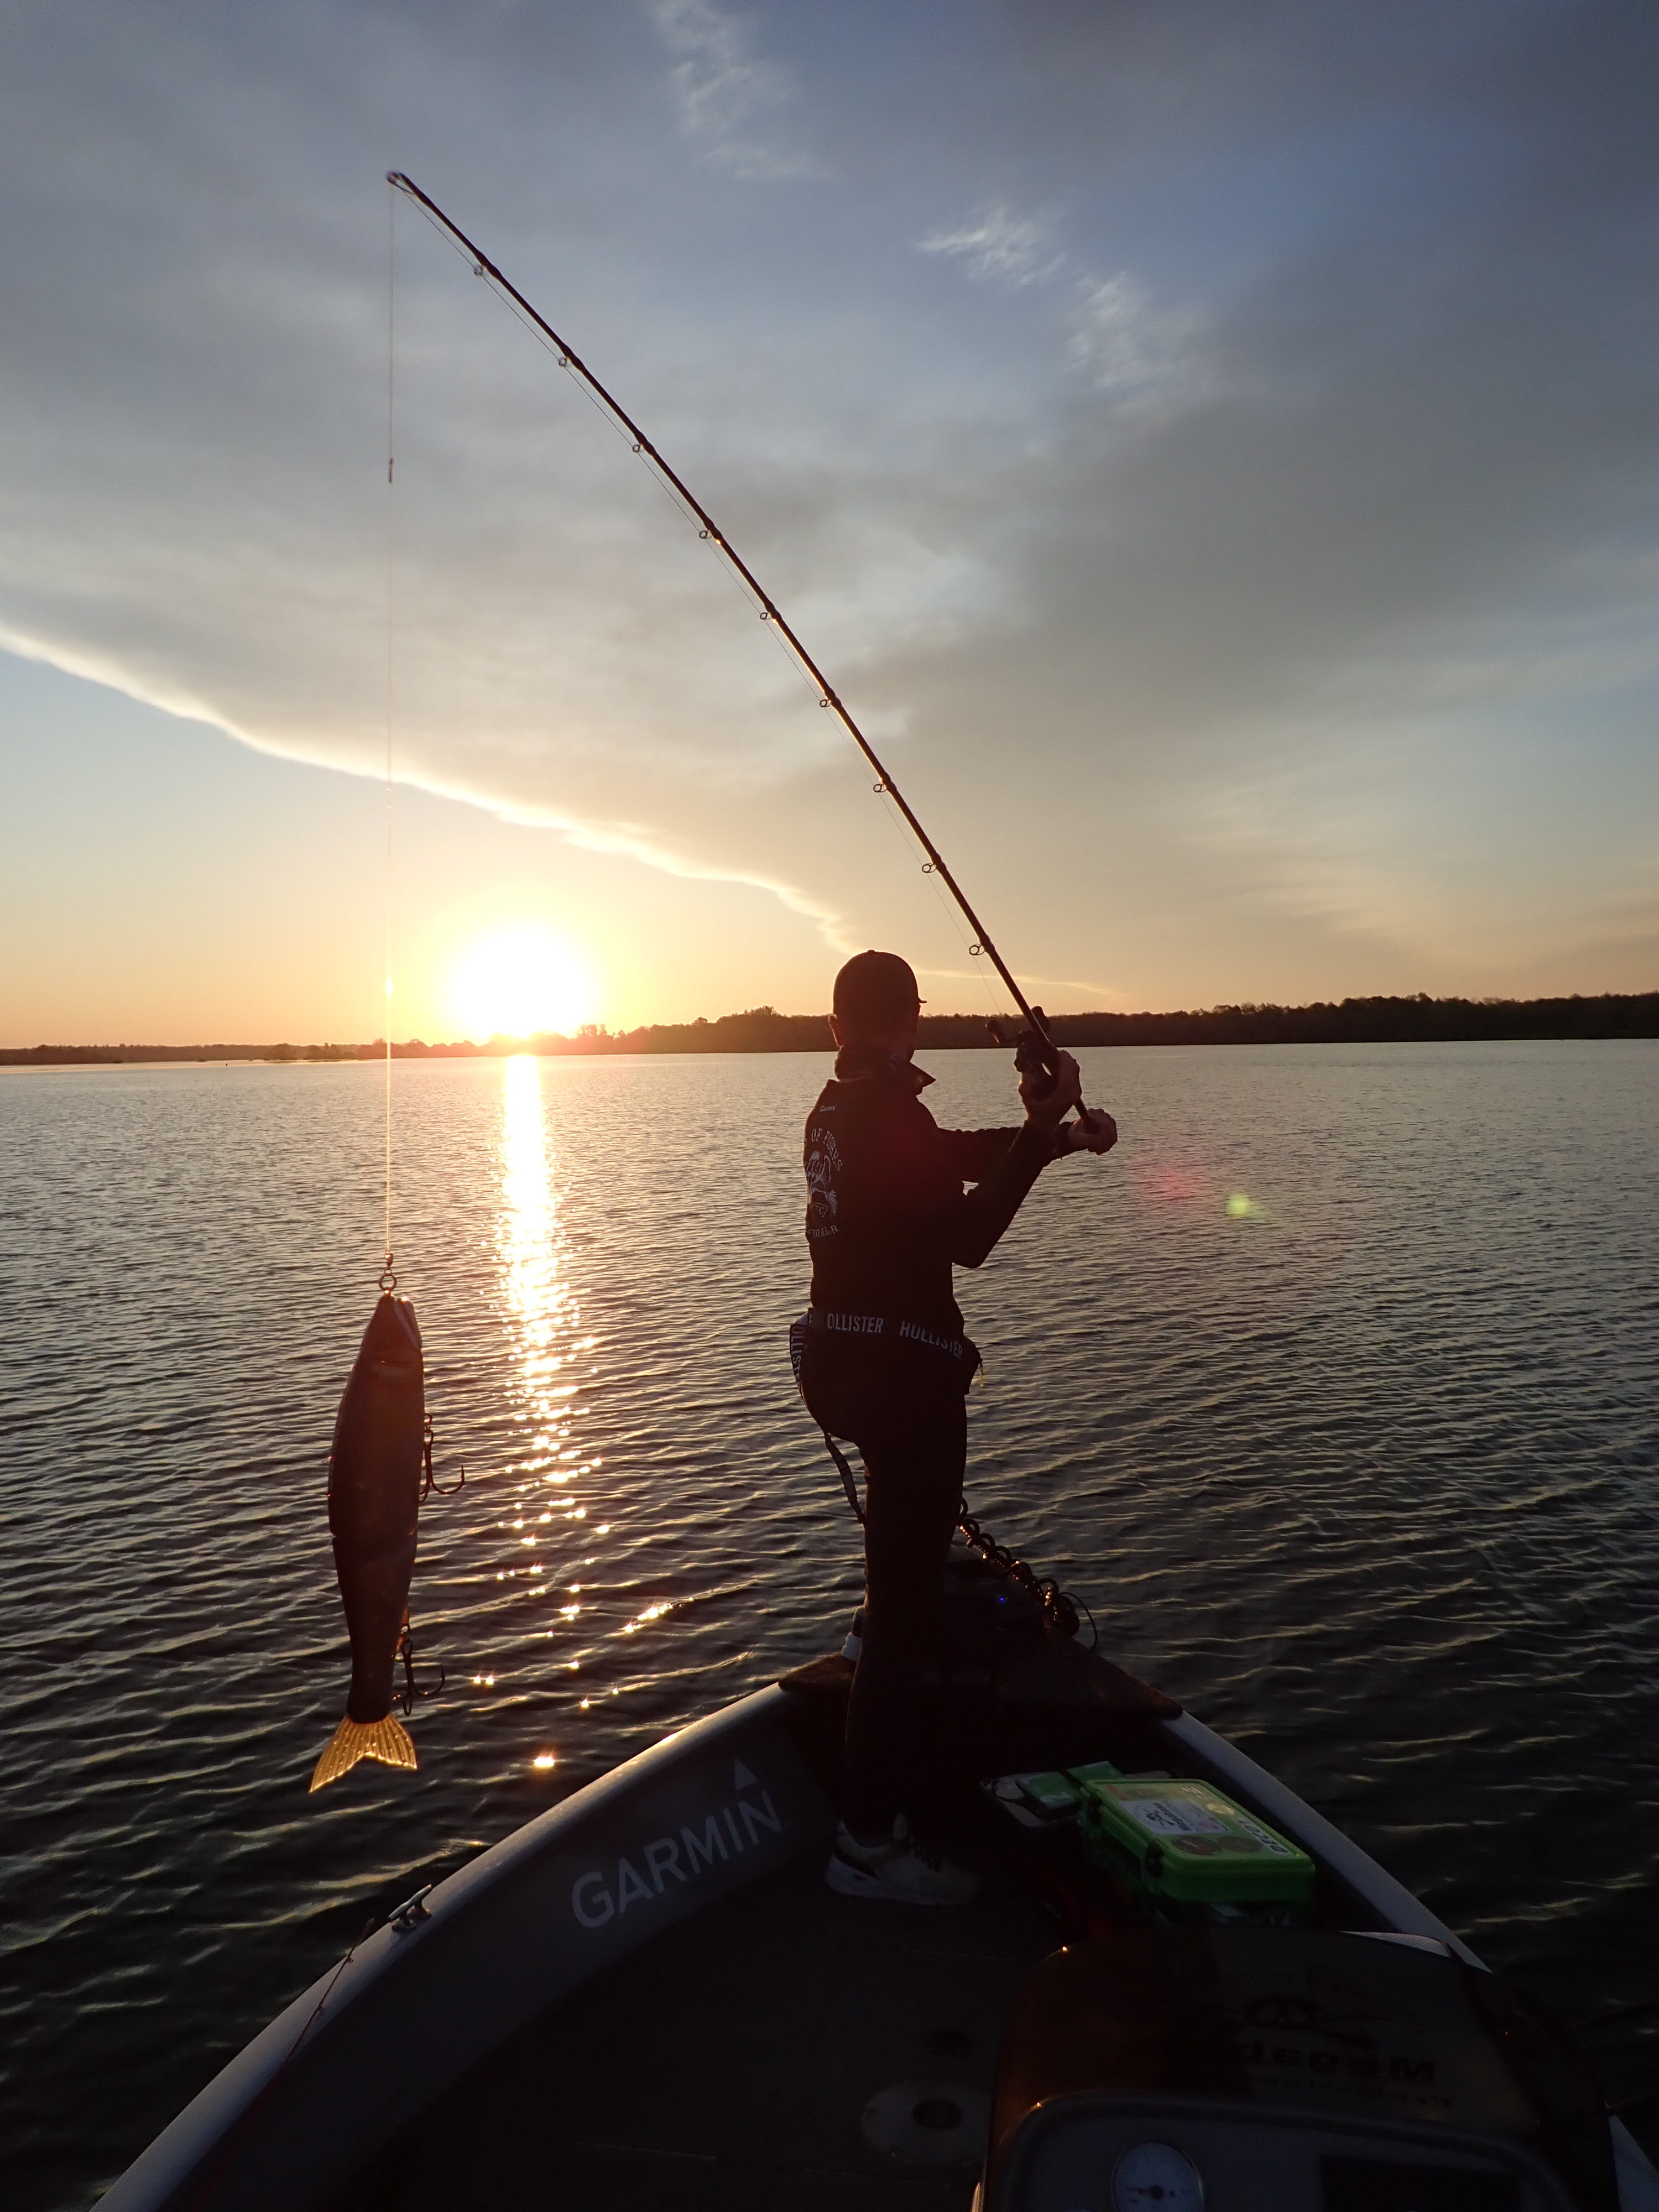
[0,991,1659,1068]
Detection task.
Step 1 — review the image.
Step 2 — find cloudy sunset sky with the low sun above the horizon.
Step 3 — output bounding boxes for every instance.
[0,0,1659,1044]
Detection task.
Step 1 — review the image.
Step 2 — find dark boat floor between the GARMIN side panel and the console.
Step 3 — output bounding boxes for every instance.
[336,1858,1055,2212]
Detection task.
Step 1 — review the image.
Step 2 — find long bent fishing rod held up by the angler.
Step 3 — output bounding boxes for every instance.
[385,168,1088,1124]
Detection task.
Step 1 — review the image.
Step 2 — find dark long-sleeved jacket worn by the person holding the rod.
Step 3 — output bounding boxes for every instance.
[805,1046,1055,1334]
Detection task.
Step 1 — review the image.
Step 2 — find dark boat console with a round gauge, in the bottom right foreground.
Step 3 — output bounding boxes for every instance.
[980,1924,1619,2212]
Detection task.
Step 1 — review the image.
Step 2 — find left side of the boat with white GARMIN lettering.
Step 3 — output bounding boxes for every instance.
[102,1688,834,2212]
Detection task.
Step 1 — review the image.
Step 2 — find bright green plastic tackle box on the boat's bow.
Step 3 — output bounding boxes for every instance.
[1077,1776,1314,1905]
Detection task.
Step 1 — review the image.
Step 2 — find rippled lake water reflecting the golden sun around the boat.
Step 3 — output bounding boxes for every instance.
[0,1042,1659,2212]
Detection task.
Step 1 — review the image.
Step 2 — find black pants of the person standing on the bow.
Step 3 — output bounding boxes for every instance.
[801,1336,967,1836]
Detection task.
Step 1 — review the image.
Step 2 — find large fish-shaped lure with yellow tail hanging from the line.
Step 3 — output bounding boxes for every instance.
[312,1292,427,1790]
